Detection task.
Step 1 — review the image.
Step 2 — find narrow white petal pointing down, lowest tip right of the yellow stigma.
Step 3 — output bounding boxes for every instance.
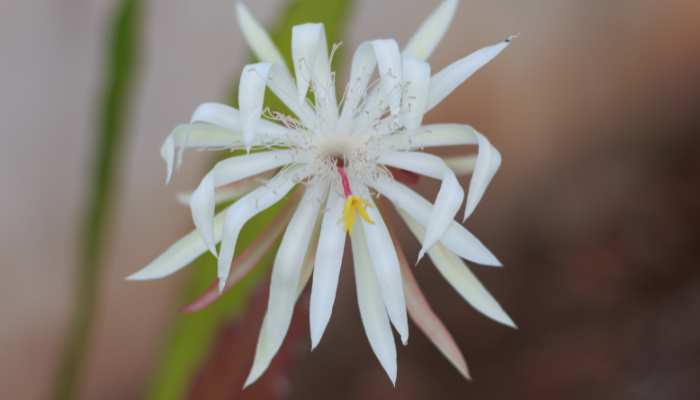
[350,225,397,384]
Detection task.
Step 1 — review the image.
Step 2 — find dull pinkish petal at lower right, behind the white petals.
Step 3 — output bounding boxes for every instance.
[392,231,471,379]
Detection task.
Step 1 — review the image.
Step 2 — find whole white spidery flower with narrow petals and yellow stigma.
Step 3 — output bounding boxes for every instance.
[129,0,513,384]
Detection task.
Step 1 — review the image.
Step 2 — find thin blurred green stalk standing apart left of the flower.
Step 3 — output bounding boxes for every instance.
[53,0,145,400]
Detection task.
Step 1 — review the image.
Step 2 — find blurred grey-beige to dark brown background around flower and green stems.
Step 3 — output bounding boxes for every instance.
[0,0,700,399]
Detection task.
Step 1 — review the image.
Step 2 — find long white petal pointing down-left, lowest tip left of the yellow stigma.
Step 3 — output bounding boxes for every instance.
[245,184,327,386]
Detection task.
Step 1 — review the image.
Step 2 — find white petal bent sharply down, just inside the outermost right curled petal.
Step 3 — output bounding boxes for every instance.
[379,152,464,261]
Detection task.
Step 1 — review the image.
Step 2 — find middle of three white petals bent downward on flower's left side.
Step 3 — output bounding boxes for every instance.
[190,150,292,255]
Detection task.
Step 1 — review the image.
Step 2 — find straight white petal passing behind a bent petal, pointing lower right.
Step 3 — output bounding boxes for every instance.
[372,179,501,267]
